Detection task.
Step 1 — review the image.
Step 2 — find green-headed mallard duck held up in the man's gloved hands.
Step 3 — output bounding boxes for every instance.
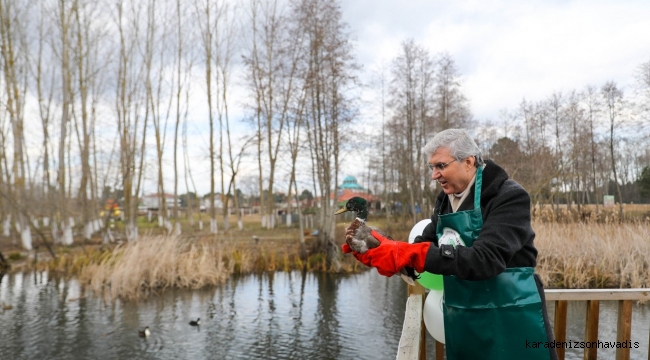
[334,196,419,285]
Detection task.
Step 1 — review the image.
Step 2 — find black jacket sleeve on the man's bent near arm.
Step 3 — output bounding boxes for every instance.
[424,183,535,280]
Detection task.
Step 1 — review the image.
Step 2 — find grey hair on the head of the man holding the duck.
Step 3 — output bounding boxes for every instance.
[422,129,483,167]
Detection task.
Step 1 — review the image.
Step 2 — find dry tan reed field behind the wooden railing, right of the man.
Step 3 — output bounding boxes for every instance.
[533,221,650,289]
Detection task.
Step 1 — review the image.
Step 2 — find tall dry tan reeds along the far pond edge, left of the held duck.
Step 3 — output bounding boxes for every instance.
[38,235,360,300]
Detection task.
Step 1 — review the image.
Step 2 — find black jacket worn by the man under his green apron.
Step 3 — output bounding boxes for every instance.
[418,160,537,280]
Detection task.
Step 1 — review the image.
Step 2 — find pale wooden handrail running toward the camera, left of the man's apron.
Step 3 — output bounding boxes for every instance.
[397,294,423,360]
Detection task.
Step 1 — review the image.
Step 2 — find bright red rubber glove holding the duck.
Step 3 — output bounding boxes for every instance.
[341,230,431,276]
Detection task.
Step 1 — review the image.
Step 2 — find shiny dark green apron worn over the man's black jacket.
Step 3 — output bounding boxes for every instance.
[436,167,549,360]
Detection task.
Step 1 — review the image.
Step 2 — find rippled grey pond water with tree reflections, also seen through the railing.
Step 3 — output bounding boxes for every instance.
[0,271,650,360]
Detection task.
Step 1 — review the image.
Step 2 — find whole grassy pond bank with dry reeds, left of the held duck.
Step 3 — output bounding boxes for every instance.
[3,224,365,299]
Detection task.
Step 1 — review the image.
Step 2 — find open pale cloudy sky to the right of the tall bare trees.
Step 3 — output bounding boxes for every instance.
[341,0,650,120]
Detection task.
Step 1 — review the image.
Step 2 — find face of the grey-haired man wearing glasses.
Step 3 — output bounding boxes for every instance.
[429,147,476,194]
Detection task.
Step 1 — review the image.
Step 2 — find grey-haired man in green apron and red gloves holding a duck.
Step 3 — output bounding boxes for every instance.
[343,129,557,360]
